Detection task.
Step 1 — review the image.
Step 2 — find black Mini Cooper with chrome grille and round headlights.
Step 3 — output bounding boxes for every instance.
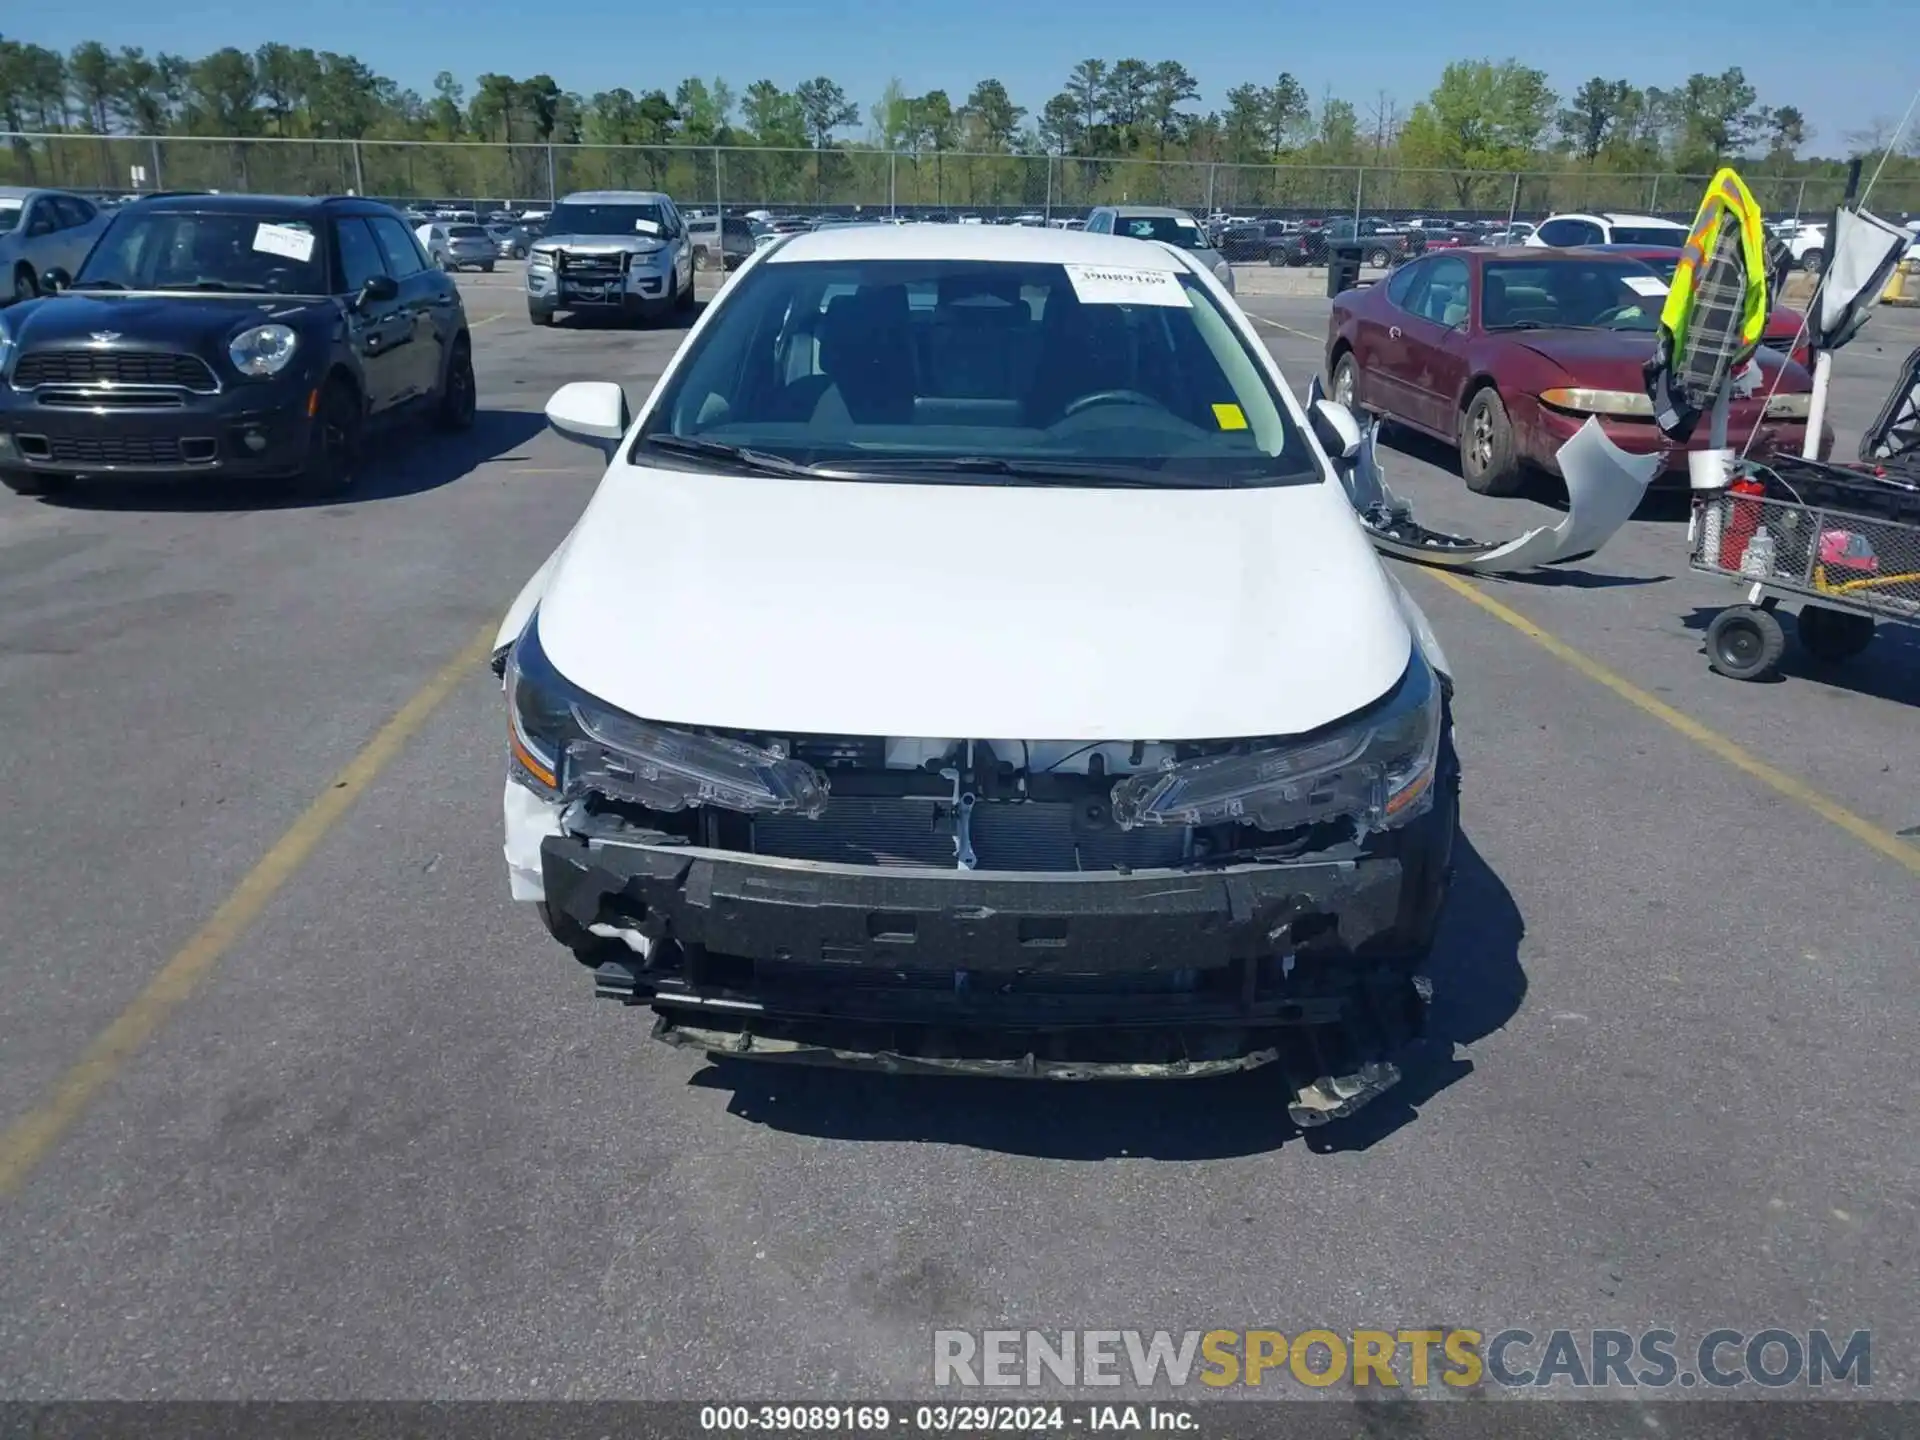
[0,194,474,495]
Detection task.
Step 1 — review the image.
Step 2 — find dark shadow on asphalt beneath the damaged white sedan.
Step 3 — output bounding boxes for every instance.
[689,835,1526,1160]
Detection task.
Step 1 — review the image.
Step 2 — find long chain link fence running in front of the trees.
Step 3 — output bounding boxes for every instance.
[0,134,1920,221]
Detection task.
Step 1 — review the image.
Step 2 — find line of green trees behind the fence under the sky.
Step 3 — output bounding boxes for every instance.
[0,38,1920,205]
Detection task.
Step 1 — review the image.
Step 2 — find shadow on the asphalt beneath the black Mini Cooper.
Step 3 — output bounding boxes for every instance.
[28,409,547,513]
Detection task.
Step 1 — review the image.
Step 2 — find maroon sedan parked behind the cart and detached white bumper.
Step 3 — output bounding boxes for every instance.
[1327,248,1834,495]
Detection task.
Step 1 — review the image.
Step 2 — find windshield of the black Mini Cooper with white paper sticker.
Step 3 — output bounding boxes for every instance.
[73,209,330,296]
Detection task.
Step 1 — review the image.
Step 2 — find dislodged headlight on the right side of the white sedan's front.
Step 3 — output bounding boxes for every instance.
[1114,647,1442,833]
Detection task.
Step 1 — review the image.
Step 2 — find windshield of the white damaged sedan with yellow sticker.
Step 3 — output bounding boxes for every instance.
[632,259,1319,488]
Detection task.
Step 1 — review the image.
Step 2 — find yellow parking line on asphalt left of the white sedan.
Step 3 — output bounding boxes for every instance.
[0,626,493,1196]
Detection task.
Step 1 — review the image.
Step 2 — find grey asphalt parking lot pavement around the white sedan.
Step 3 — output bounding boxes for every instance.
[0,273,1920,1400]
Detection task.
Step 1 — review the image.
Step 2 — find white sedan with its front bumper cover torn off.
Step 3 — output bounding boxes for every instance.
[495,225,1459,1125]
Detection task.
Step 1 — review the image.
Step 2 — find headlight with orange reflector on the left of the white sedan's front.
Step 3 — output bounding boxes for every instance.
[505,616,828,818]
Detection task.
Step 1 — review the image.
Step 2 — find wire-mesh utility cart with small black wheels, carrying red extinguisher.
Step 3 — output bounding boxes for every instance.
[1688,455,1920,680]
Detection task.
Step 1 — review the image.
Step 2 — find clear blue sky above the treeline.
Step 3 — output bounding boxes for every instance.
[8,0,1920,152]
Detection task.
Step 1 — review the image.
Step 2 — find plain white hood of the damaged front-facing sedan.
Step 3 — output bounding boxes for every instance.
[538,470,1413,739]
